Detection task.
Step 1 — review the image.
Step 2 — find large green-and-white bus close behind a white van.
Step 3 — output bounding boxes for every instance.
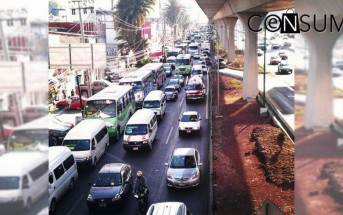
[83,85,136,140]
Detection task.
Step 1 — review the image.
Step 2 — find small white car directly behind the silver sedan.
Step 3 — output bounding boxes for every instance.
[179,111,201,135]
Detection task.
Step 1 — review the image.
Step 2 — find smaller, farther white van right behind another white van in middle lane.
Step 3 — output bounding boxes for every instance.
[143,90,167,120]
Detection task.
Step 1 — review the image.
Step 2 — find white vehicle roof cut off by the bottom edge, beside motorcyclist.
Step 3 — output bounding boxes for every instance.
[146,202,191,215]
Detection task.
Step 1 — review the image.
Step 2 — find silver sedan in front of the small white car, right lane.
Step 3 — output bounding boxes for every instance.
[165,148,202,188]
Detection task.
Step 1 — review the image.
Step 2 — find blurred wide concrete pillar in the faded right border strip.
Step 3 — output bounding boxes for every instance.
[304,31,339,129]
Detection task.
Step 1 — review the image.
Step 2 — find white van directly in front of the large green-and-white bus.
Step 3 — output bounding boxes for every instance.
[62,119,109,168]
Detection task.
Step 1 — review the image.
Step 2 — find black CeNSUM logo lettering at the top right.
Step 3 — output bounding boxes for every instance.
[248,10,343,34]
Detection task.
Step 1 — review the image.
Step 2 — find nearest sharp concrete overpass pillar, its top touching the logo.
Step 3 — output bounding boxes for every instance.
[238,13,266,101]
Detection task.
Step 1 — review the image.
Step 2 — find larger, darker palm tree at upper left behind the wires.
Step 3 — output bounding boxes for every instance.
[114,0,155,51]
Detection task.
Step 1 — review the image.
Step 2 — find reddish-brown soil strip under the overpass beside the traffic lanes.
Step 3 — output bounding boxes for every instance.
[212,76,294,215]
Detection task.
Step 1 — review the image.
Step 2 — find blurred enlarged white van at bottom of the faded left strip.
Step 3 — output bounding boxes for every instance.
[0,151,49,210]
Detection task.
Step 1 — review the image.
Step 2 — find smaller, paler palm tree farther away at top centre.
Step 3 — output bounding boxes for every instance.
[162,0,185,36]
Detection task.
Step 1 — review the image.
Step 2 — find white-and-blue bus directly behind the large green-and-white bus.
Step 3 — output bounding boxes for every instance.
[119,70,155,108]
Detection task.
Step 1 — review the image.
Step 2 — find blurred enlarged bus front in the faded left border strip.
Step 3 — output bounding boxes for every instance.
[6,115,49,152]
